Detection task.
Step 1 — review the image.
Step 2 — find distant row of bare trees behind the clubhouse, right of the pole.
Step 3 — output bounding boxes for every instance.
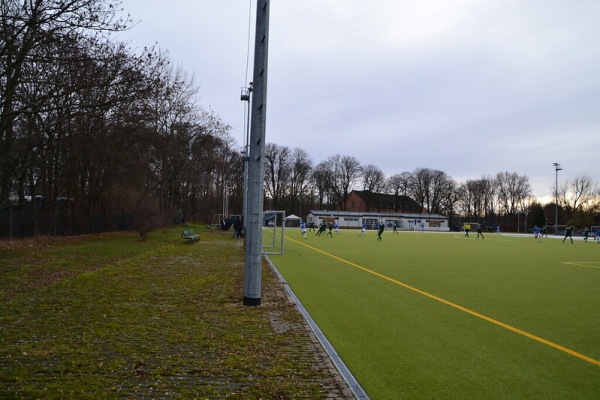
[265,144,600,230]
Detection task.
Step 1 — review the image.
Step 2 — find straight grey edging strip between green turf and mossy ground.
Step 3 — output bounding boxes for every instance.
[265,255,369,400]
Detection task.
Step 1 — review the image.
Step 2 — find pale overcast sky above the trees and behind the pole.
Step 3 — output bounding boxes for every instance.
[116,0,600,201]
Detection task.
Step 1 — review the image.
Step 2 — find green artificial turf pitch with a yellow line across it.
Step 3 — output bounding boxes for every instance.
[271,230,600,399]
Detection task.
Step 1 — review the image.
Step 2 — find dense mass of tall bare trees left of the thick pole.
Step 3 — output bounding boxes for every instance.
[0,0,243,235]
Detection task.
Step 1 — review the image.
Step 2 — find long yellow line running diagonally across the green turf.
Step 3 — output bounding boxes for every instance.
[286,237,600,366]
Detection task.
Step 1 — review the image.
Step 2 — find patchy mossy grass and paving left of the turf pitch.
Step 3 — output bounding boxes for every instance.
[0,227,344,399]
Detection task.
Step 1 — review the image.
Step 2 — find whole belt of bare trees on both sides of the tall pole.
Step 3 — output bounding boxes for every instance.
[0,0,600,236]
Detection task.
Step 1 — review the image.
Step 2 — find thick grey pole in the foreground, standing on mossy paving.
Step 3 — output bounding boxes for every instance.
[243,0,269,306]
